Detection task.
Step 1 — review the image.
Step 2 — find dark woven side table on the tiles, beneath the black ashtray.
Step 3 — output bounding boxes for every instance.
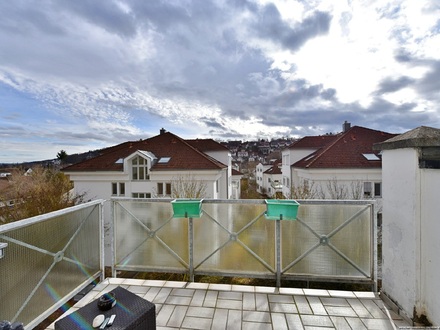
[55,286,156,330]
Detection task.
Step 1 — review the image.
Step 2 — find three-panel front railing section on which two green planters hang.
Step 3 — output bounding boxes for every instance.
[112,198,377,290]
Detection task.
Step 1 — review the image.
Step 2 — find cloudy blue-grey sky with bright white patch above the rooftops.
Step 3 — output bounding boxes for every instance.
[0,0,440,163]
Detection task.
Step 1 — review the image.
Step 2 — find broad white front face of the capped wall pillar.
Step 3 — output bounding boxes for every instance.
[382,149,420,318]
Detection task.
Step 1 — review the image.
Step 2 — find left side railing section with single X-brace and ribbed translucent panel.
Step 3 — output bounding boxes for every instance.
[0,200,104,329]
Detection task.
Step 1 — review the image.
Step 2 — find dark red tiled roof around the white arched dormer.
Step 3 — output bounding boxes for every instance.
[63,132,227,172]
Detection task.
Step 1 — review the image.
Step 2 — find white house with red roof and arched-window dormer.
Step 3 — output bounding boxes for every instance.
[63,129,234,209]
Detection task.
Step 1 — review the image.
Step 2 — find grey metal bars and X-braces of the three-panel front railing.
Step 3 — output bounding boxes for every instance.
[112,198,377,291]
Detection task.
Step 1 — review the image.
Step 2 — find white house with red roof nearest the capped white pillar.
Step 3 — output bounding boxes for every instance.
[282,122,395,208]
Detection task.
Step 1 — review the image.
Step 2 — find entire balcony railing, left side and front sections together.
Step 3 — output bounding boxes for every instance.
[0,198,376,329]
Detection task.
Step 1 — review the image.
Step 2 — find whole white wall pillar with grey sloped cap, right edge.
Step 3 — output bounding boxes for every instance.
[377,126,440,326]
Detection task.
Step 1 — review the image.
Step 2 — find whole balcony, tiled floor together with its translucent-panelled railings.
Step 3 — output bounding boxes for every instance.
[0,198,408,329]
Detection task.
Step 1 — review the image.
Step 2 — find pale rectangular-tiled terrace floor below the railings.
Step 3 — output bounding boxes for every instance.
[47,278,409,330]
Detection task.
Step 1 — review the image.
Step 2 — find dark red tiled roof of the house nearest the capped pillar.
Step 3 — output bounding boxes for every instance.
[292,126,396,168]
